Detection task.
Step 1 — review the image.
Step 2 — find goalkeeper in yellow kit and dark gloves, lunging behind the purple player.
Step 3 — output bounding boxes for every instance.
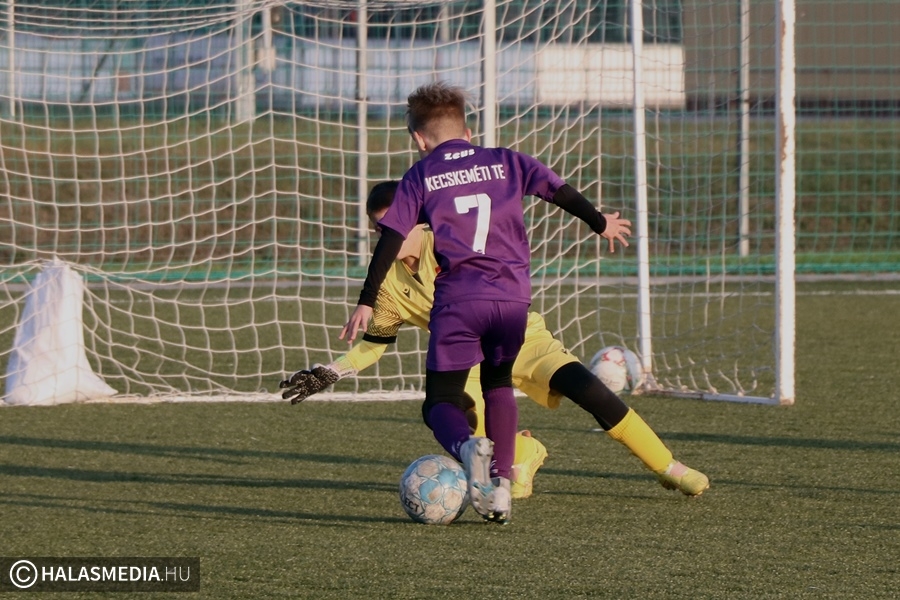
[281,181,709,498]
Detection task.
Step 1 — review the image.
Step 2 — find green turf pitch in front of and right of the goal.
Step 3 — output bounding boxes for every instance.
[0,282,900,599]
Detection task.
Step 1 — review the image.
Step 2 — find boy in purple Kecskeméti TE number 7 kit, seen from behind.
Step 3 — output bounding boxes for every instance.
[340,82,630,523]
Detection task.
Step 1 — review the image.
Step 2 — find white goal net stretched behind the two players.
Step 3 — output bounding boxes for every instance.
[0,0,796,406]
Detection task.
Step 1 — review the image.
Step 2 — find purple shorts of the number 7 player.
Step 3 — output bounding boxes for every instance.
[425,300,529,371]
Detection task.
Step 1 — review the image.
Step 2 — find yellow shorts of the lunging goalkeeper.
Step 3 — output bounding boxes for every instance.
[466,312,579,435]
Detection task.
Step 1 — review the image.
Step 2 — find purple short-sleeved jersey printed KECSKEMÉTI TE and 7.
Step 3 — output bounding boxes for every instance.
[379,140,565,306]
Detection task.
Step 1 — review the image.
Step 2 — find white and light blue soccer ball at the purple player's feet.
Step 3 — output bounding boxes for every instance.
[400,454,469,525]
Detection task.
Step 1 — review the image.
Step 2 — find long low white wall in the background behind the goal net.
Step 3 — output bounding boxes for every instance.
[0,33,685,110]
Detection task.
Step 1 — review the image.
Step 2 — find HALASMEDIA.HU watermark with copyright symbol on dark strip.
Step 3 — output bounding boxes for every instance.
[0,556,200,592]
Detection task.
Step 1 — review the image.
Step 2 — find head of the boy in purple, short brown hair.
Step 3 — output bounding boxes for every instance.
[406,81,472,158]
